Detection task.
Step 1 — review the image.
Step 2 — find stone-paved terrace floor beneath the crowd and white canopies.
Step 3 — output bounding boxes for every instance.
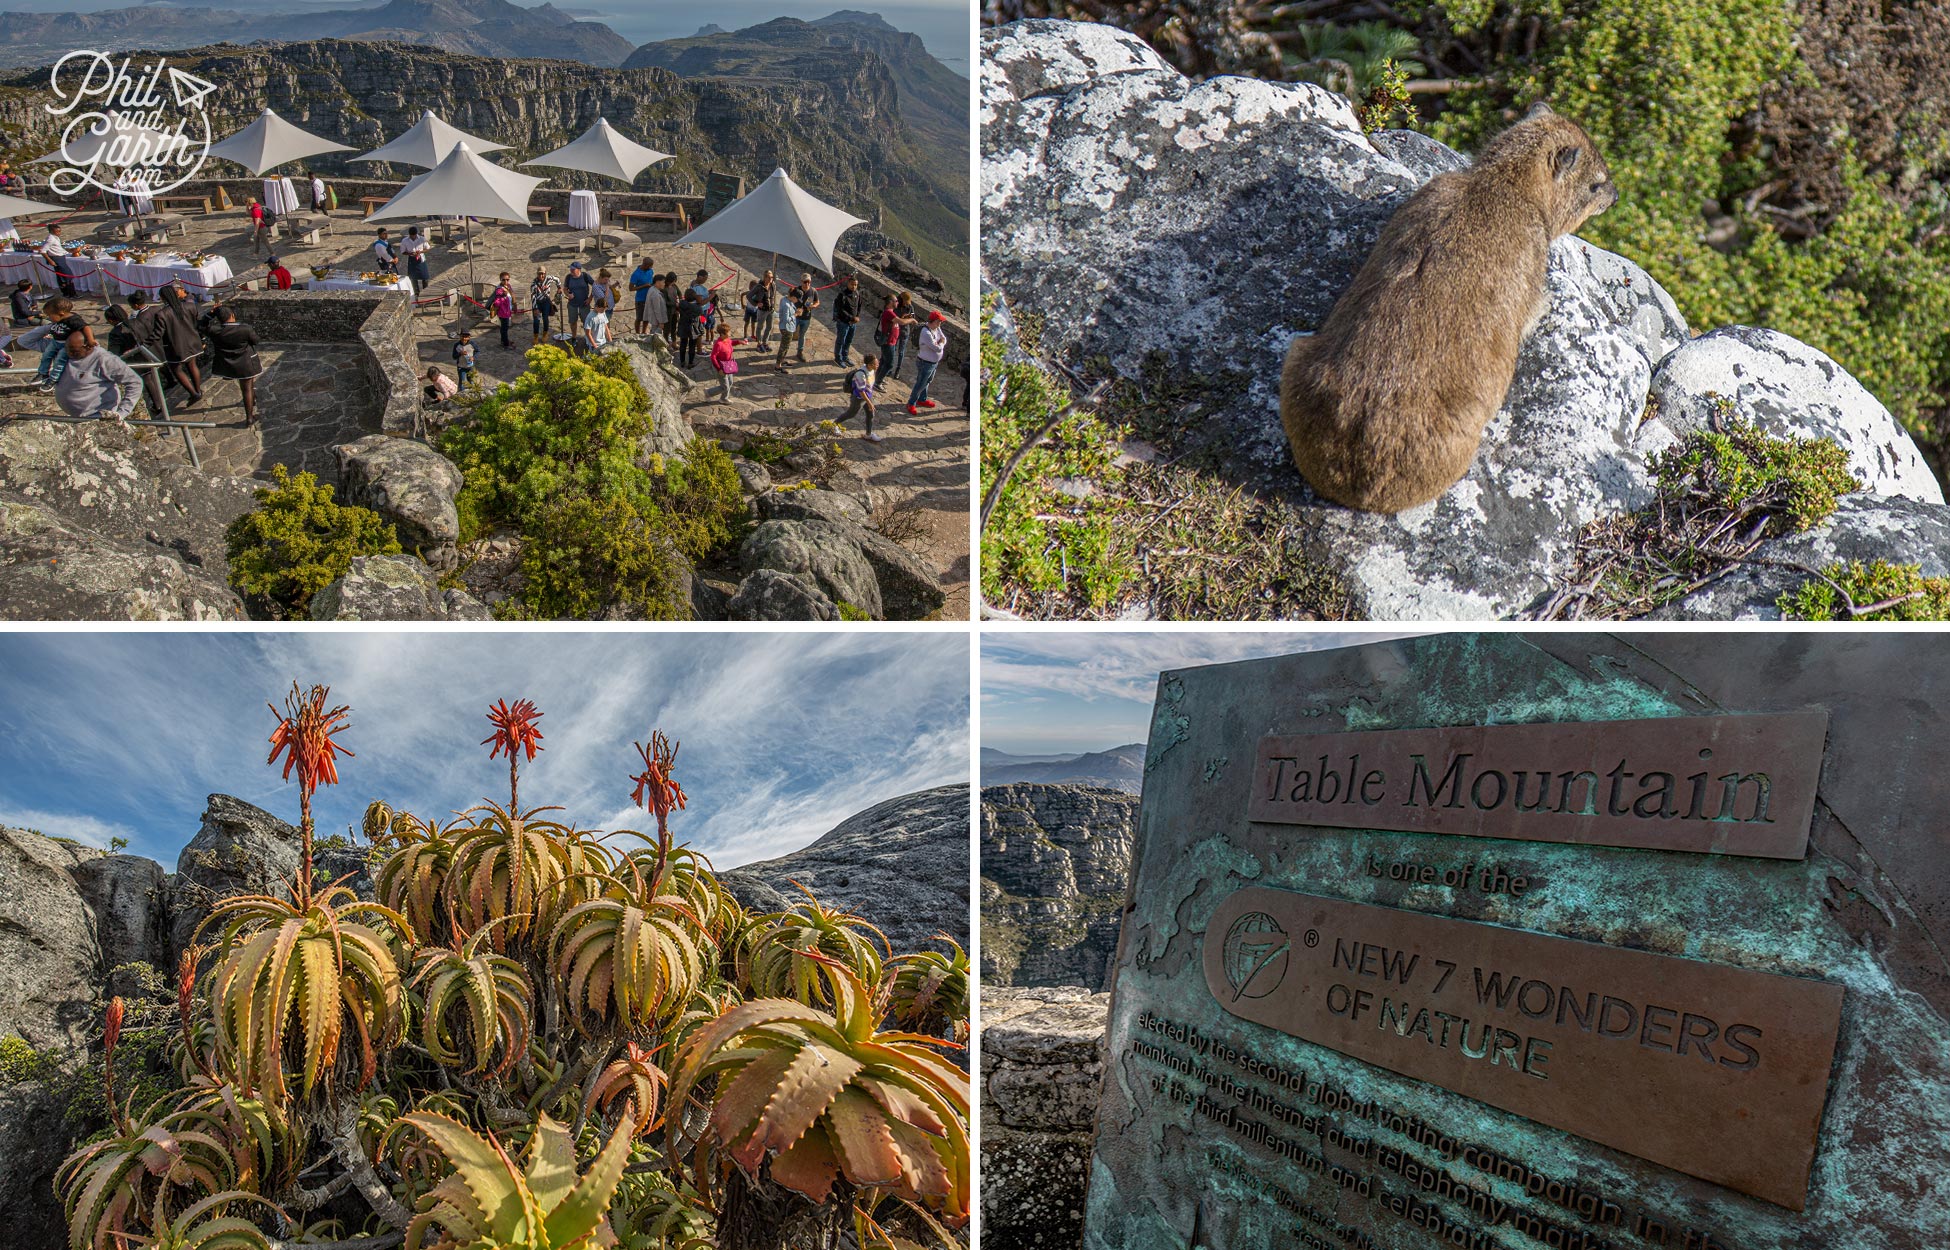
[0,195,969,620]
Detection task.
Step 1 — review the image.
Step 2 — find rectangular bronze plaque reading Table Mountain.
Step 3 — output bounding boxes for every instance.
[1248,712,1827,860]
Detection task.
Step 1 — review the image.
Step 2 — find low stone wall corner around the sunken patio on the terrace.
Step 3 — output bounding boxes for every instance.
[230,291,419,437]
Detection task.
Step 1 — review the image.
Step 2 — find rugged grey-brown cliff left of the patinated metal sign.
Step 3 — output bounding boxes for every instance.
[981,784,1137,989]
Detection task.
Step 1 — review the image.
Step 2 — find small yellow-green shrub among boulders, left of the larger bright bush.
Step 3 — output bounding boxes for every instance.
[224,464,400,620]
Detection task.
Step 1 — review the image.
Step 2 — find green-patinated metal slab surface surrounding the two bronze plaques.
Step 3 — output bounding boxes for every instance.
[1086,634,1950,1250]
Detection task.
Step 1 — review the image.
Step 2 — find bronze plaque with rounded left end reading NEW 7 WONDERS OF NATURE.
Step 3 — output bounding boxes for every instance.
[1205,885,1843,1211]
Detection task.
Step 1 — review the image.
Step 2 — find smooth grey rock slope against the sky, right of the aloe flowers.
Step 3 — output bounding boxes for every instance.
[720,786,969,954]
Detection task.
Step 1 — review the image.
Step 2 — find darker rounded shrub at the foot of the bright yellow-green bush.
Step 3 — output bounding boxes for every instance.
[501,495,690,620]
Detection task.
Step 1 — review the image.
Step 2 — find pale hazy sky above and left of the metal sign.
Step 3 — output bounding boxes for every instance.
[981,630,1402,755]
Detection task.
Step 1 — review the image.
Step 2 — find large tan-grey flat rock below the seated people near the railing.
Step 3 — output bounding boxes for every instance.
[0,421,254,620]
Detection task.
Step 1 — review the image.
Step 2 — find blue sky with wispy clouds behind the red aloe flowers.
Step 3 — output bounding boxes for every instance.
[0,632,969,868]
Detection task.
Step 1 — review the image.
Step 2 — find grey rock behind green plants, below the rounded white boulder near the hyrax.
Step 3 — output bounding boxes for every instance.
[1650,495,1950,620]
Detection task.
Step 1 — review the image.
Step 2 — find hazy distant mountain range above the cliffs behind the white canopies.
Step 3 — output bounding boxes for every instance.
[0,0,630,66]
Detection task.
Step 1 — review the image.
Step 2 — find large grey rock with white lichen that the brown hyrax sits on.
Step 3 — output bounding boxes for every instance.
[979,21,1940,620]
